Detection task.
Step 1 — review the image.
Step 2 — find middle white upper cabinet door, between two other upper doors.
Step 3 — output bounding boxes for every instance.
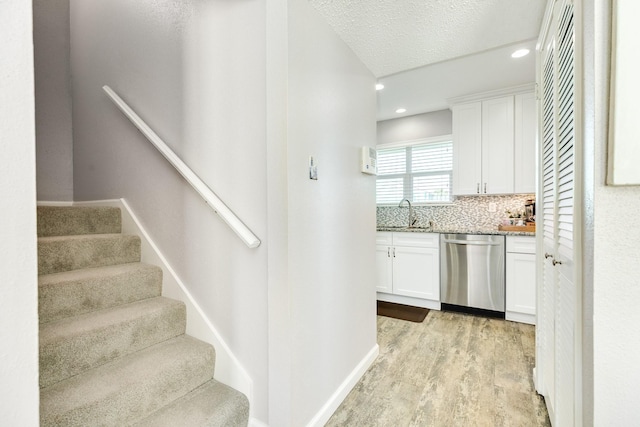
[480,96,514,194]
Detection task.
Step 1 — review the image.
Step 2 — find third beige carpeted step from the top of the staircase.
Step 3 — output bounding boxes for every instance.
[38,263,162,323]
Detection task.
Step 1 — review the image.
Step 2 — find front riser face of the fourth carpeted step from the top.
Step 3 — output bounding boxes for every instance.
[40,304,186,387]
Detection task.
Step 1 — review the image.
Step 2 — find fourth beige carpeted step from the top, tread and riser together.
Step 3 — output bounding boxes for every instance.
[40,297,186,387]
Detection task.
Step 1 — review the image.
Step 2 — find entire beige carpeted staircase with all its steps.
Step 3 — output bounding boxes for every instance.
[38,207,249,427]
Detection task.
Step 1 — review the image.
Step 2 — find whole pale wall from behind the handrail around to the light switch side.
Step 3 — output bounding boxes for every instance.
[71,0,376,426]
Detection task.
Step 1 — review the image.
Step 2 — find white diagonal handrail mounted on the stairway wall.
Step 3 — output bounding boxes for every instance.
[102,85,260,248]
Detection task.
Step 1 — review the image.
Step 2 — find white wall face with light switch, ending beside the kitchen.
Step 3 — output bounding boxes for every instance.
[284,0,376,426]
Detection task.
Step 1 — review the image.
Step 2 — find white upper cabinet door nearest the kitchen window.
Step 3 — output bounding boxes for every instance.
[452,102,482,195]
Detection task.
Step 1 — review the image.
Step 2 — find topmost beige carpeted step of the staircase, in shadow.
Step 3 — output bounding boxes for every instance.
[37,206,122,237]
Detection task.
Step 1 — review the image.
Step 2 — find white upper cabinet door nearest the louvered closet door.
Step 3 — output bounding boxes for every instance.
[513,92,537,193]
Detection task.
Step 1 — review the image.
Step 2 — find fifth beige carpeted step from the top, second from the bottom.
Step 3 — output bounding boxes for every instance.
[40,335,215,427]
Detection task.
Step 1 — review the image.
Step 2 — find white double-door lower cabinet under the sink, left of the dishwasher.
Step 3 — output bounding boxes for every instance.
[376,232,440,309]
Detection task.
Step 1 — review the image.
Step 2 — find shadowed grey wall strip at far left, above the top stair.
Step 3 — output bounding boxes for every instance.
[33,0,73,201]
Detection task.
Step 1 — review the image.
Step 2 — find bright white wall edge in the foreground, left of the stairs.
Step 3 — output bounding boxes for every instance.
[0,0,40,426]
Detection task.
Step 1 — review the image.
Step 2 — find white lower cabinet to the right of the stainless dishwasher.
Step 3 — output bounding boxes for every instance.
[505,236,536,325]
